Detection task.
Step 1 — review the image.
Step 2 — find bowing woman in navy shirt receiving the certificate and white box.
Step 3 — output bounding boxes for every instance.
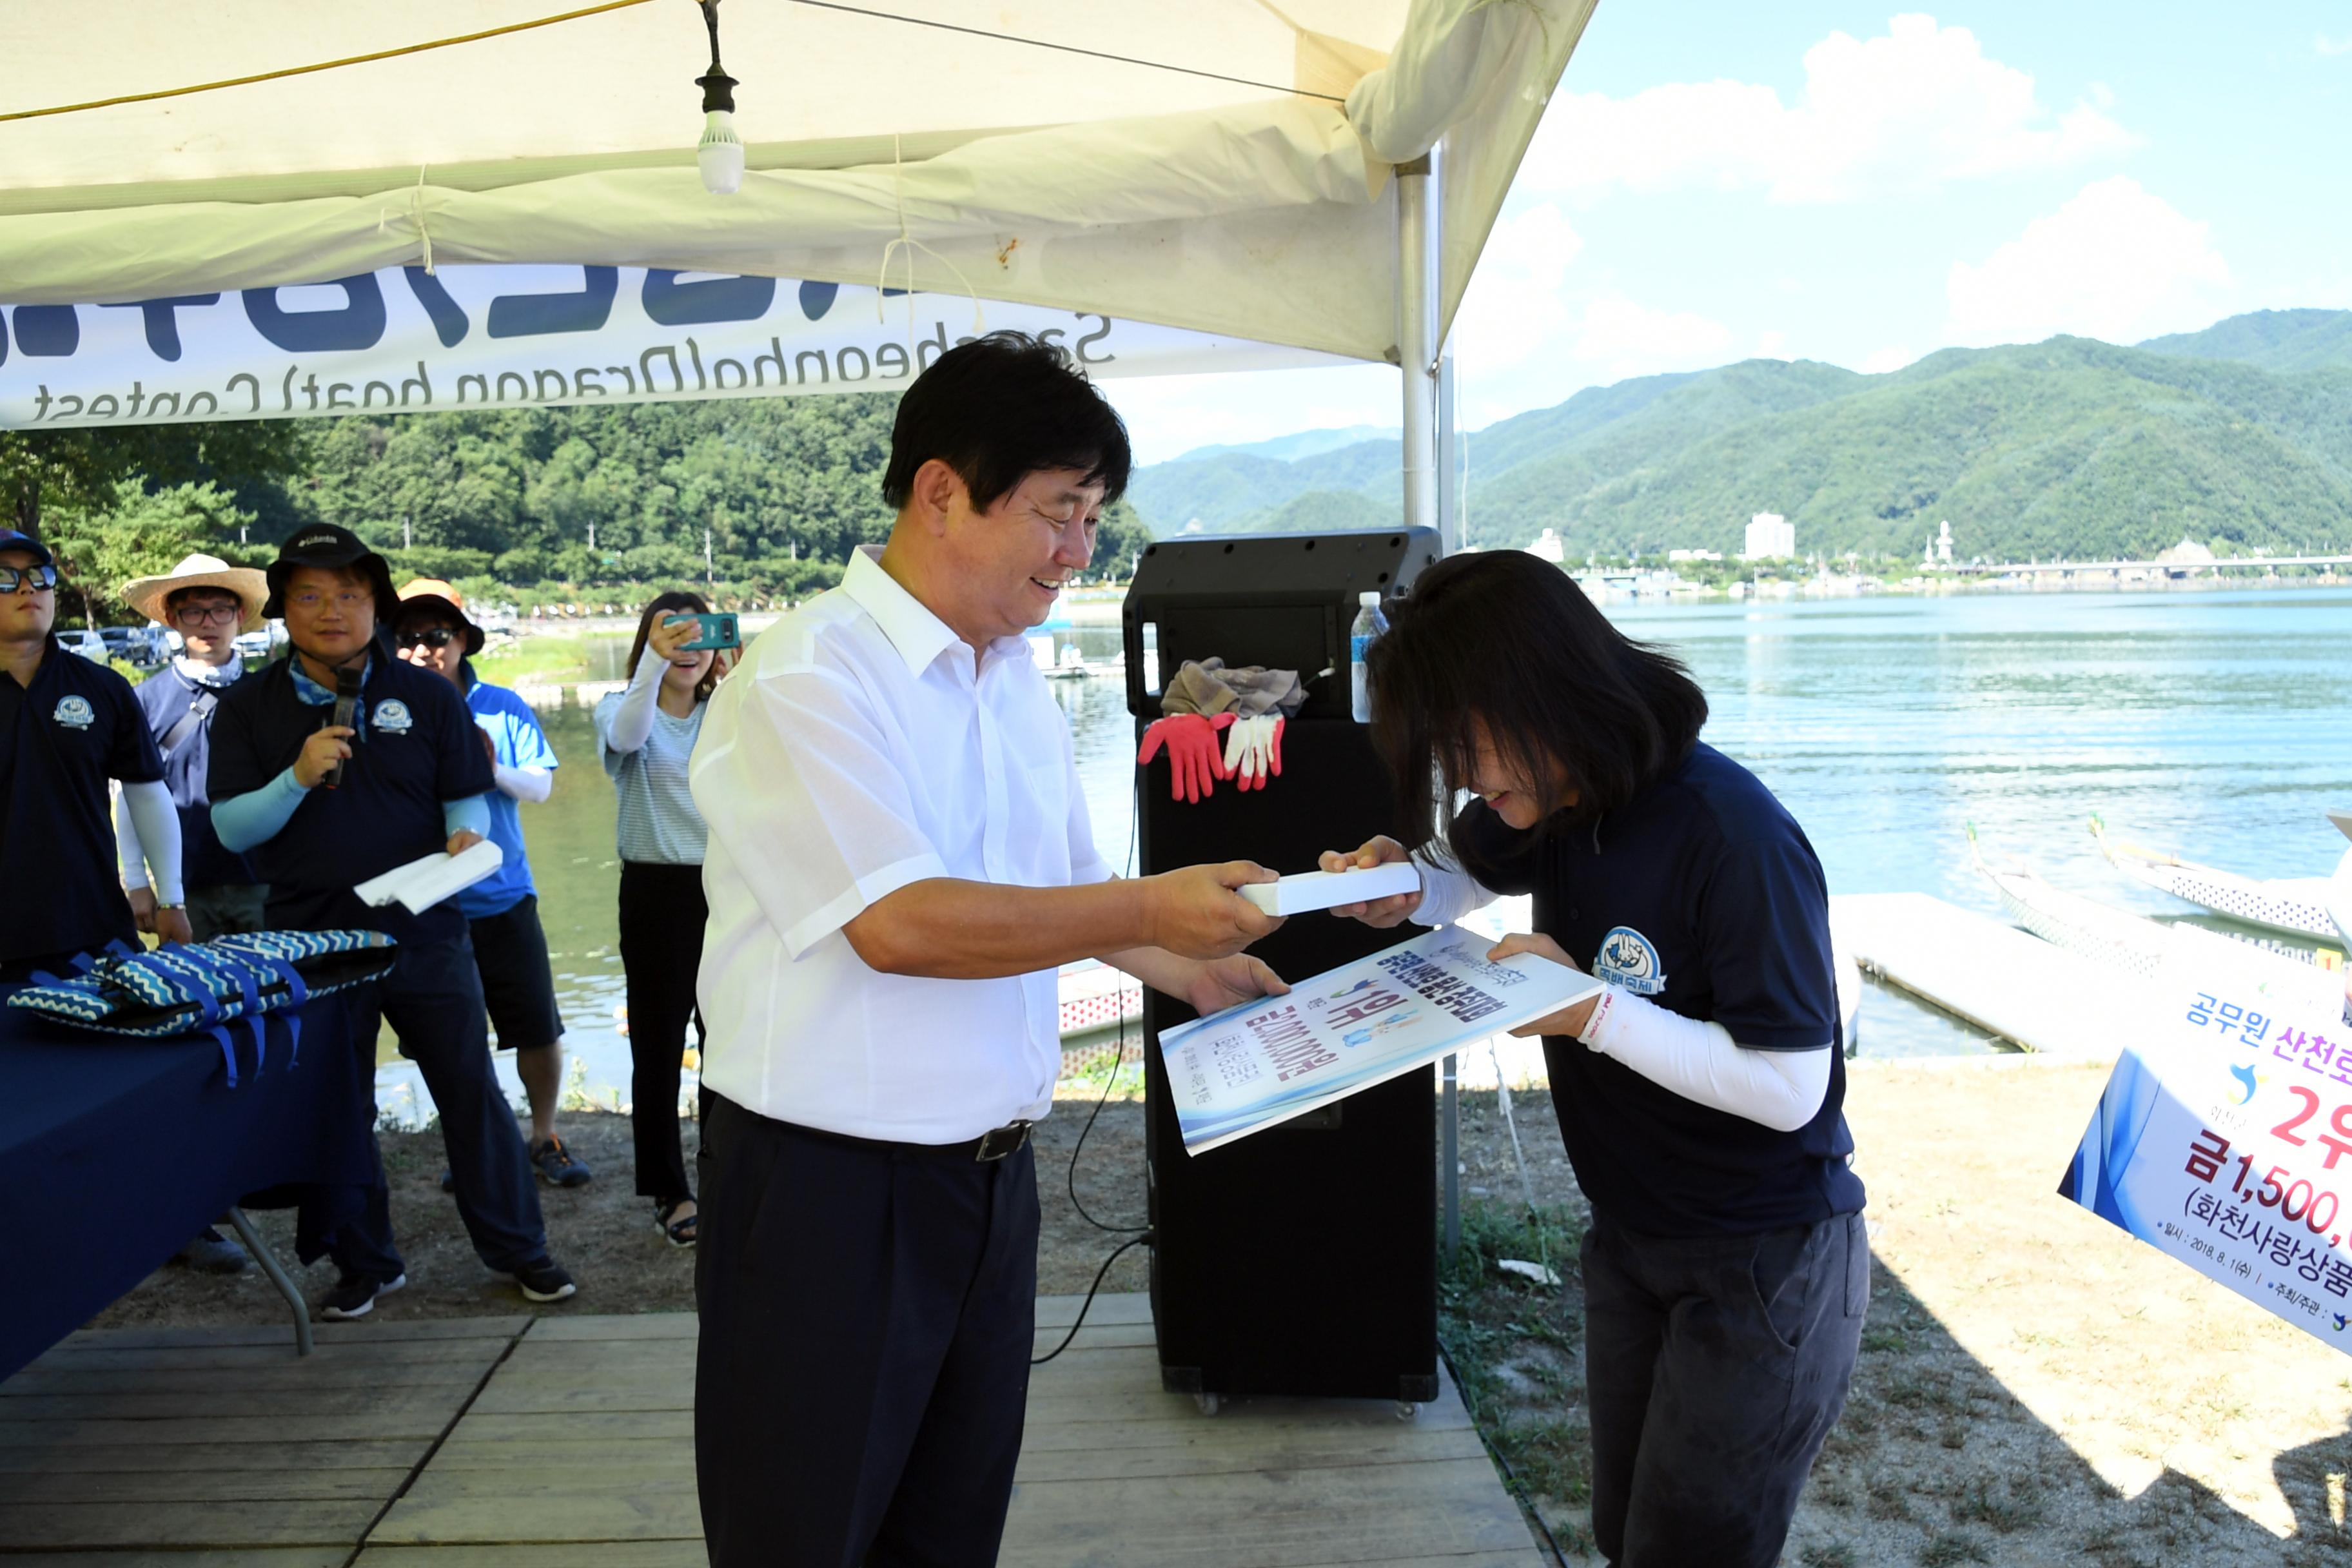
[1322,550,1870,1568]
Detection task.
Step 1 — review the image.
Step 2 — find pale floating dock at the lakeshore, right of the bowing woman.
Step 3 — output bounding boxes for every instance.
[1830,894,2145,1060]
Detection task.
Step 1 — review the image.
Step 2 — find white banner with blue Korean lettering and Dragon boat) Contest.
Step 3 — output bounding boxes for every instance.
[0,266,1346,430]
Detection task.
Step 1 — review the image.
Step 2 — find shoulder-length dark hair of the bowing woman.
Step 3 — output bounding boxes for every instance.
[1366,550,1707,867]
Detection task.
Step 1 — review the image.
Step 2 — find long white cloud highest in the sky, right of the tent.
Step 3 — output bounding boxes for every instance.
[1520,17,2141,202]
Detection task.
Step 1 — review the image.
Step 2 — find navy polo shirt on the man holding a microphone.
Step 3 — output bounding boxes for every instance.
[210,654,496,943]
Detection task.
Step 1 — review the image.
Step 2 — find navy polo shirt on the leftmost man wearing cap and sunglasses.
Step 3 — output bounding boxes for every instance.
[0,637,162,961]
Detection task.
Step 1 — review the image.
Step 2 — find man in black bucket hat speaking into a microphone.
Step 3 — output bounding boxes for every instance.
[211,524,574,1319]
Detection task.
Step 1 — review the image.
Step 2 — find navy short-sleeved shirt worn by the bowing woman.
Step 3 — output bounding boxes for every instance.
[1460,745,1863,1237]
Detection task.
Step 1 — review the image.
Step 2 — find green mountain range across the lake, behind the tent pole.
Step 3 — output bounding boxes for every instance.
[1129,310,2352,560]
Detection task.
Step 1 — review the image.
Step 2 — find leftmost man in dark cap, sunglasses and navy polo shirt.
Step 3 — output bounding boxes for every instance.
[0,529,188,983]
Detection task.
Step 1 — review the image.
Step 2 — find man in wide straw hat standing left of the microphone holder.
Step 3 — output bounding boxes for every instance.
[115,554,268,1274]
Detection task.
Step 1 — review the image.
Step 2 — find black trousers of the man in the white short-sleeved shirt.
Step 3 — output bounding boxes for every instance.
[694,1093,1037,1568]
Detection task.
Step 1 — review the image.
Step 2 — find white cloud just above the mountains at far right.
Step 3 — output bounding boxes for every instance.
[1945,174,2230,343]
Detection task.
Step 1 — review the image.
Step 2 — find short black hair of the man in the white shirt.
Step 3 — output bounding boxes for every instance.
[882,331,1133,513]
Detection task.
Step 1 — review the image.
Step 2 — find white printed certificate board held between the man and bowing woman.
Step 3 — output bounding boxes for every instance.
[1159,926,1602,1154]
